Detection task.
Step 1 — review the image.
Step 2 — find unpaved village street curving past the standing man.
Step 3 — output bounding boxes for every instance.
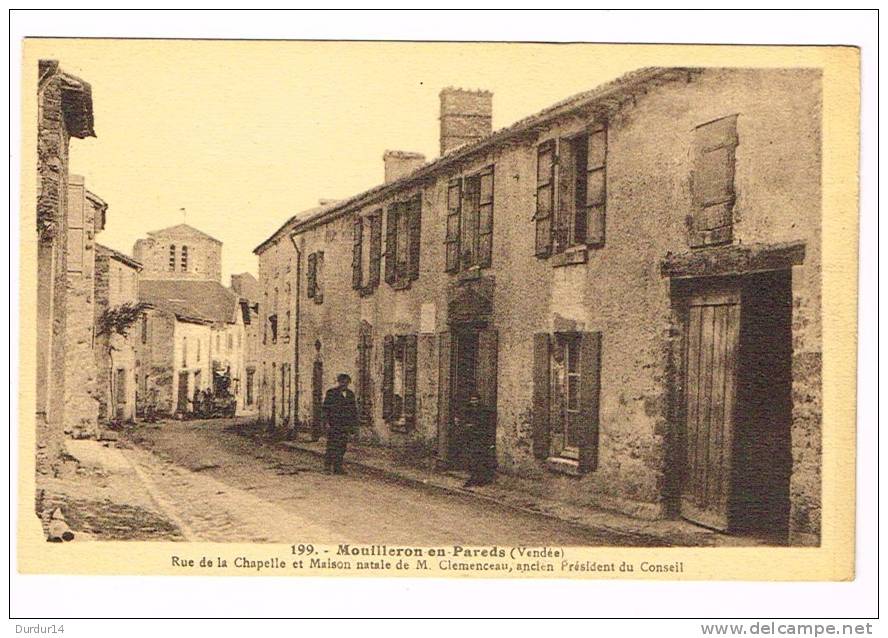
[122,419,664,546]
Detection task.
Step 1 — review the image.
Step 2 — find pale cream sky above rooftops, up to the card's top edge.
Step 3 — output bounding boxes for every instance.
[24,39,668,283]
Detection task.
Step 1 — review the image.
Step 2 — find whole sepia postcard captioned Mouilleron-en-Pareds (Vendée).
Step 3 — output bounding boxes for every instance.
[17,38,859,580]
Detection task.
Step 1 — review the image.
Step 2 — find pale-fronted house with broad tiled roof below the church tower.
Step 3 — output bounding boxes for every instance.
[137,279,246,414]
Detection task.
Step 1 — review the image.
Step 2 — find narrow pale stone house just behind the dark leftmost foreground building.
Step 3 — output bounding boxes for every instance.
[64,175,108,438]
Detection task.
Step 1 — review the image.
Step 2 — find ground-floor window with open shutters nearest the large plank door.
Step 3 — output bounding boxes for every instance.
[533,332,601,472]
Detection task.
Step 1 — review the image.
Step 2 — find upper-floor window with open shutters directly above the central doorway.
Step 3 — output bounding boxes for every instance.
[444,166,493,272]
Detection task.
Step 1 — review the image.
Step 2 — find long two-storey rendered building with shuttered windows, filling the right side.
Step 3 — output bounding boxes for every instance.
[257,68,822,545]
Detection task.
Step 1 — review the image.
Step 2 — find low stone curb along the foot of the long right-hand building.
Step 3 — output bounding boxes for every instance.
[277,441,674,547]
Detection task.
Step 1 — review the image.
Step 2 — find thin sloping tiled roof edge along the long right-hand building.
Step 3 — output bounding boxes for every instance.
[284,67,700,238]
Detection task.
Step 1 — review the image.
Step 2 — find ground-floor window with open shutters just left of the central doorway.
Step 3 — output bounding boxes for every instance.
[382,335,417,428]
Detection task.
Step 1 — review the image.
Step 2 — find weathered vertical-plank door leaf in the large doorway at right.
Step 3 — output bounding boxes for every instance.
[681,291,740,530]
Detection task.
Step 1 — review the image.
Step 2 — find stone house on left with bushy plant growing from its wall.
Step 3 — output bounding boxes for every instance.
[94,244,142,422]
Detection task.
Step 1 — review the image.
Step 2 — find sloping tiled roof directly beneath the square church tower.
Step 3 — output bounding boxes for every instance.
[139,279,240,323]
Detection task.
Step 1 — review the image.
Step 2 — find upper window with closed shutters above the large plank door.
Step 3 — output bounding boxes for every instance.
[688,115,739,248]
